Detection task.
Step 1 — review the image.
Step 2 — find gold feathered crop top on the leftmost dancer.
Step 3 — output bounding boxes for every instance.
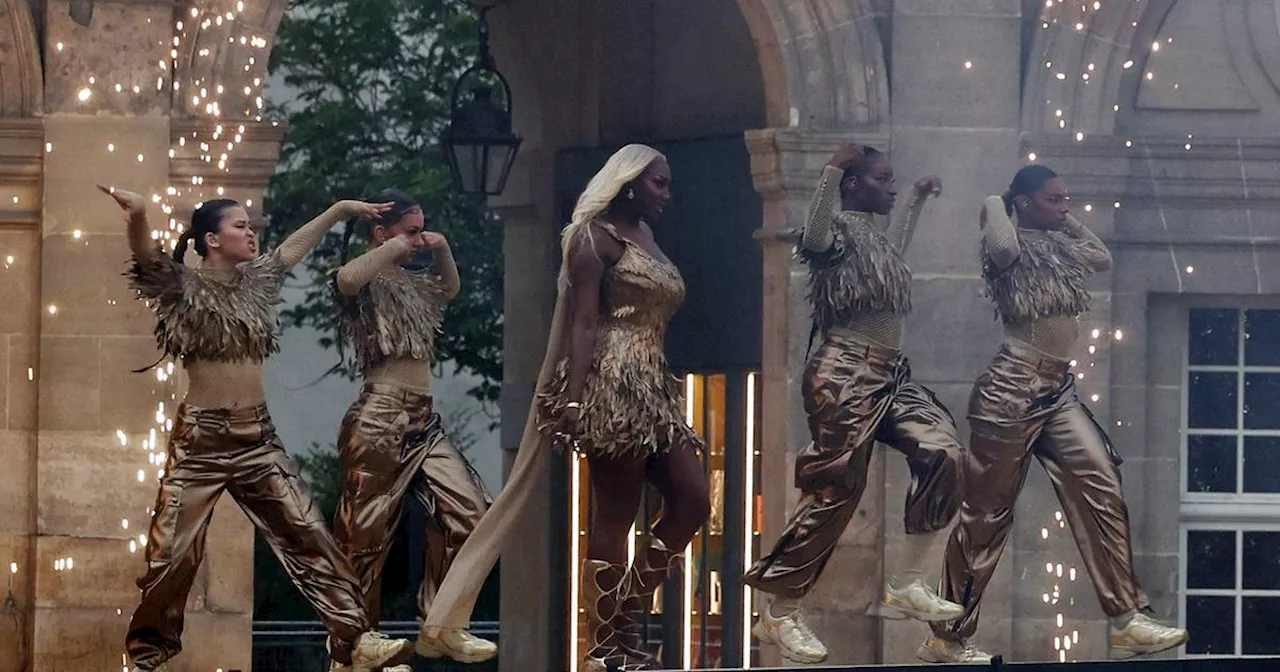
[125,250,289,364]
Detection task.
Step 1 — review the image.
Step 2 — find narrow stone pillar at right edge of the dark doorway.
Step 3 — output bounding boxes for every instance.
[746,128,887,666]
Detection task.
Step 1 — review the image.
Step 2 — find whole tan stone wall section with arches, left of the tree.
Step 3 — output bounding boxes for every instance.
[0,0,285,672]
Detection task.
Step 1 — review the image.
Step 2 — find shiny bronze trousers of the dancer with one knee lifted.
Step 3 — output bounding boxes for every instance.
[744,333,964,598]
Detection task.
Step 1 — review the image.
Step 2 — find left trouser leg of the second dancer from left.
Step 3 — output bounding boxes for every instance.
[333,394,412,627]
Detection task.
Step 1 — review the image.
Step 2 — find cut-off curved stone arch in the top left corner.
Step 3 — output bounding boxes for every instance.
[0,0,44,116]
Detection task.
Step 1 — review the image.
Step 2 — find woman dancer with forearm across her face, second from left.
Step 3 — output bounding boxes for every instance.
[334,189,498,663]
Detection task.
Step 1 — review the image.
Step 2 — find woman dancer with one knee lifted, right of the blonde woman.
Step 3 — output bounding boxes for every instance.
[744,145,964,663]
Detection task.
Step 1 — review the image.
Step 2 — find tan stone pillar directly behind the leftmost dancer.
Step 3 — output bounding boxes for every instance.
[30,0,283,672]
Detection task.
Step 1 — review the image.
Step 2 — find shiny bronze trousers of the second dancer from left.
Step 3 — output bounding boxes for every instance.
[334,383,490,623]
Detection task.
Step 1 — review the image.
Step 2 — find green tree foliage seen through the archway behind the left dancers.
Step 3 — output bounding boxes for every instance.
[266,0,502,402]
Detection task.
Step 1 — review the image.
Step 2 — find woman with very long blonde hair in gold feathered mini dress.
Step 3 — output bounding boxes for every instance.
[414,145,710,672]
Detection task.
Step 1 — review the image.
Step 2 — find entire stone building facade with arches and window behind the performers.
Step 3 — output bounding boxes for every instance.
[0,0,1280,672]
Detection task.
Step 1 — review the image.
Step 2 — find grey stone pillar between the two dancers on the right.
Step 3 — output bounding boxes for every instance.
[883,0,1024,663]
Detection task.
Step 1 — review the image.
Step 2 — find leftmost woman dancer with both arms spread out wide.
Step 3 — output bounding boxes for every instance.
[99,186,412,672]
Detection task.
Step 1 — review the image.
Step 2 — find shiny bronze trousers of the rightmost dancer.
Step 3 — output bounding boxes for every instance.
[933,339,1147,640]
